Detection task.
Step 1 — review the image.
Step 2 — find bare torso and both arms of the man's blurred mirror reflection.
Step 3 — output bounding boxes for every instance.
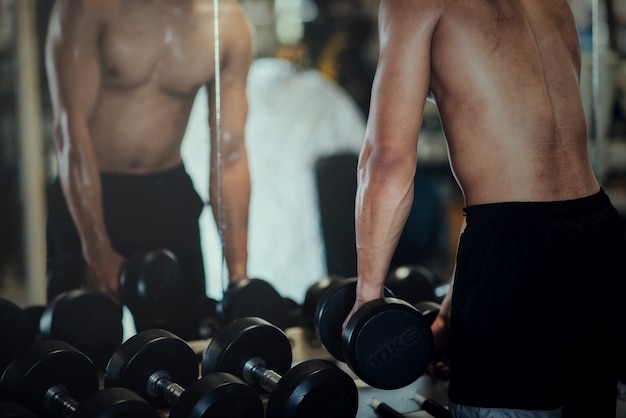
[46,0,253,301]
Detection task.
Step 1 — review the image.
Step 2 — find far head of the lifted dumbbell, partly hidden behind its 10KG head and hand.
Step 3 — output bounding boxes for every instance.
[315,277,393,362]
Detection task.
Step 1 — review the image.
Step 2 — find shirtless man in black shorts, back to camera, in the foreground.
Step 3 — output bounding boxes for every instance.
[346,0,626,417]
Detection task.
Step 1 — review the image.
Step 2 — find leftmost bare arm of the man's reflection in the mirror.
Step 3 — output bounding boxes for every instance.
[46,0,123,300]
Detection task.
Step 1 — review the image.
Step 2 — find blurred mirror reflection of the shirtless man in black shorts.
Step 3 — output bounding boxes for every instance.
[47,0,253,340]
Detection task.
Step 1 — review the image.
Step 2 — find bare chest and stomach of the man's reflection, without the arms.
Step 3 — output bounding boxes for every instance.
[90,0,221,173]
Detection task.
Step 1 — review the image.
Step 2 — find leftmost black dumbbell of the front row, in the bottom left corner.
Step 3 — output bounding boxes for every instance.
[0,340,159,418]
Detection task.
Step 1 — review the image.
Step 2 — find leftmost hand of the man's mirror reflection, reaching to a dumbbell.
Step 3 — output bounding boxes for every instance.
[85,252,126,305]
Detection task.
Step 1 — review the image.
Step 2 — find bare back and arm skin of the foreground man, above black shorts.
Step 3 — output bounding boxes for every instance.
[350,0,600,356]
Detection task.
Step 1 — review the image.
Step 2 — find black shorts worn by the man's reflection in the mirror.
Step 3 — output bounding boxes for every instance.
[47,165,206,337]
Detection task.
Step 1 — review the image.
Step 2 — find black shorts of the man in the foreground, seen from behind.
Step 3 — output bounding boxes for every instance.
[449,191,626,418]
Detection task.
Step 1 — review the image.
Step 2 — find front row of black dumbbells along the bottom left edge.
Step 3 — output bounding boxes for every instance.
[0,317,358,418]
